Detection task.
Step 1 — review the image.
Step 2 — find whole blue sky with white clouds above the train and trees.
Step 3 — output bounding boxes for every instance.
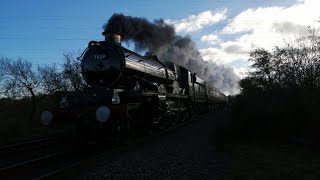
[0,0,320,94]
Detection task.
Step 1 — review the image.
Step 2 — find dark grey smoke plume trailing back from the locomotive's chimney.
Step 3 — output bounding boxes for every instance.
[103,14,239,94]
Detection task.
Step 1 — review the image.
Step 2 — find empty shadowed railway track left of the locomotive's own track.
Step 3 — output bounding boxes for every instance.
[0,137,75,179]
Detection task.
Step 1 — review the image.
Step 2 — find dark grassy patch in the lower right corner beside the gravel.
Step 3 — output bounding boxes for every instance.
[225,142,320,180]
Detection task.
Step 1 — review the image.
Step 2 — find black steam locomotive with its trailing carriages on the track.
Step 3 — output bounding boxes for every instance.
[41,32,227,140]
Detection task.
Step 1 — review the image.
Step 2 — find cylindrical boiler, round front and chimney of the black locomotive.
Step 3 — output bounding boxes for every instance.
[80,33,177,91]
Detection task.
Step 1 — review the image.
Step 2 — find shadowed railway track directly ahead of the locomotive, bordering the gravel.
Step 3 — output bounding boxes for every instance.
[0,143,116,180]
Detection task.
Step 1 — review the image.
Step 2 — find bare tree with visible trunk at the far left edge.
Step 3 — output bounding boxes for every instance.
[0,58,40,122]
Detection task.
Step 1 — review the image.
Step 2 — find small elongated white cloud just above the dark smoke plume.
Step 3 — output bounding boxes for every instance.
[165,9,227,32]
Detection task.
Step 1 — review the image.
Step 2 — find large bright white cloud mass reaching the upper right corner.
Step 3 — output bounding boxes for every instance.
[200,0,320,77]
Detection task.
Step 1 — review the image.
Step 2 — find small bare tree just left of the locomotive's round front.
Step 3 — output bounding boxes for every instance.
[63,52,86,91]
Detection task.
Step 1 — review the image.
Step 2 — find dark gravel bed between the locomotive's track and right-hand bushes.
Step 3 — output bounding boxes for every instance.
[63,112,228,179]
